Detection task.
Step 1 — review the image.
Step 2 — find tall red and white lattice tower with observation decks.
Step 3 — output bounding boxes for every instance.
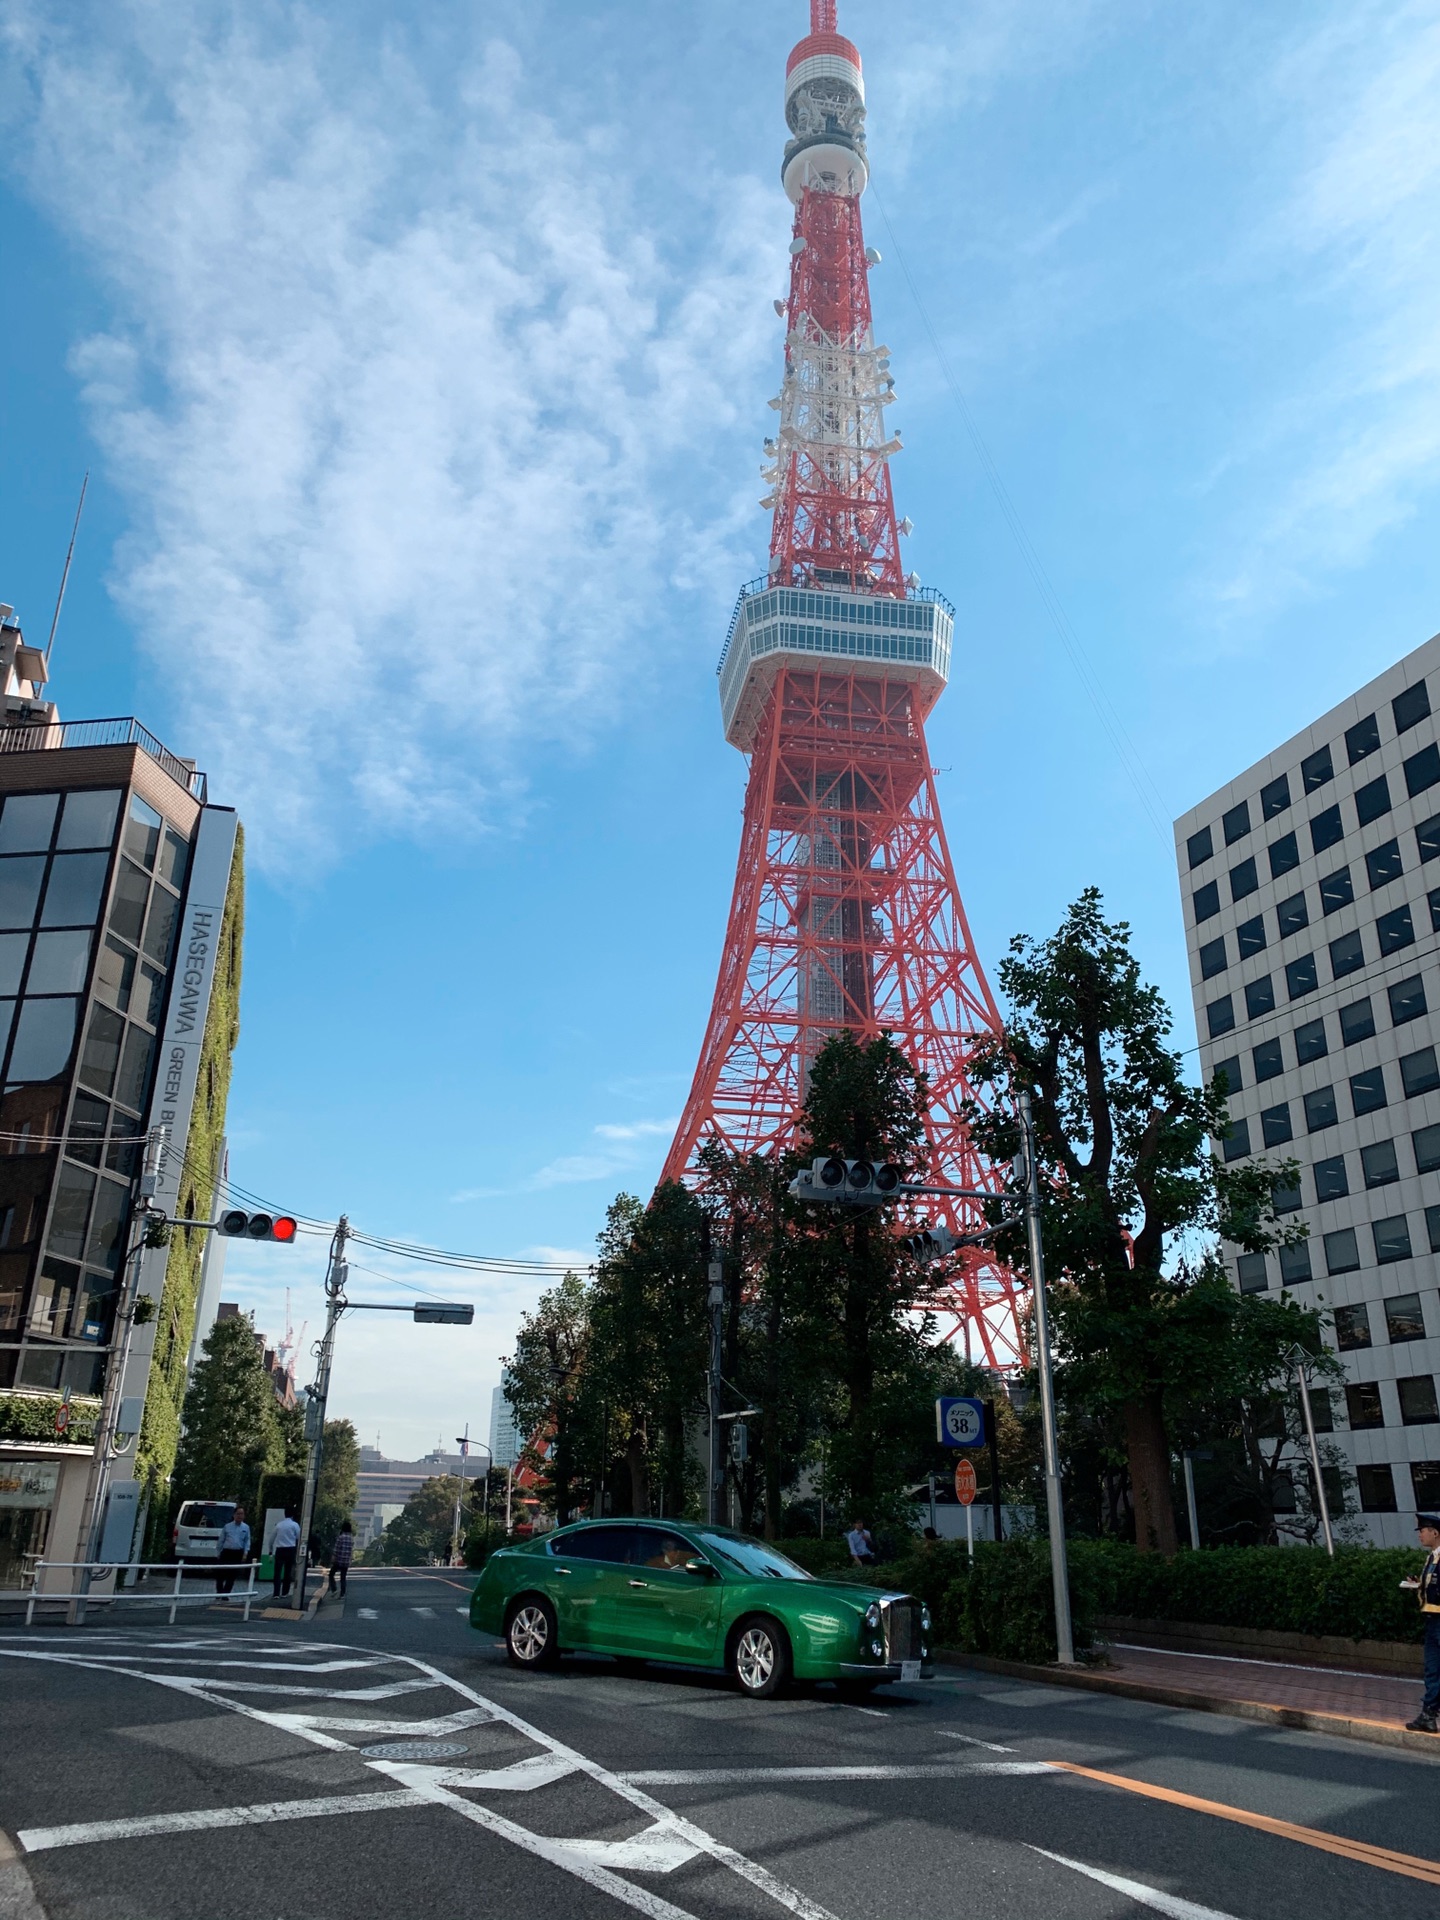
[662,0,1021,1367]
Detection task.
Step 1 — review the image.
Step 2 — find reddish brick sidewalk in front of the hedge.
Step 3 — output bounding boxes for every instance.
[939,1644,1440,1761]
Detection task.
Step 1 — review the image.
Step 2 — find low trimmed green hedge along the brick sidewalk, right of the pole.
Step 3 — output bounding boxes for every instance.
[1069,1540,1425,1642]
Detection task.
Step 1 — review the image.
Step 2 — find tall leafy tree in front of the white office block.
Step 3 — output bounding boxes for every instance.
[968,887,1327,1553]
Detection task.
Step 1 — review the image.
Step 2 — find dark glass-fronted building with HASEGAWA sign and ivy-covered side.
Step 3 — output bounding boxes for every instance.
[0,607,242,1588]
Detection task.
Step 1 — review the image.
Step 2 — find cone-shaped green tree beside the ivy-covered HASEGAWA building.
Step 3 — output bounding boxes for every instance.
[173,1313,284,1509]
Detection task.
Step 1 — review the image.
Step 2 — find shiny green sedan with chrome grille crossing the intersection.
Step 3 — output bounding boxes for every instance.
[470,1521,931,1699]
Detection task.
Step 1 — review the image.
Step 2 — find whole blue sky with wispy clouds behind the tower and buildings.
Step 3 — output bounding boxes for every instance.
[0,0,1440,1455]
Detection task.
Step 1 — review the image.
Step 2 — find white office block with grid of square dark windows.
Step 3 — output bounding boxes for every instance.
[1175,636,1440,1546]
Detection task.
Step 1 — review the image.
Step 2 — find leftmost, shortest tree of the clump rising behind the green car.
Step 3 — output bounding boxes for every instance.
[501,1273,595,1526]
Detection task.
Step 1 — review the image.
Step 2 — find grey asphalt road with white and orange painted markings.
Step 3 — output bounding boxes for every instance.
[0,1571,1440,1920]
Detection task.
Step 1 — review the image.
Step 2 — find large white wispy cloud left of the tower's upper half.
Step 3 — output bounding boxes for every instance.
[0,0,776,868]
